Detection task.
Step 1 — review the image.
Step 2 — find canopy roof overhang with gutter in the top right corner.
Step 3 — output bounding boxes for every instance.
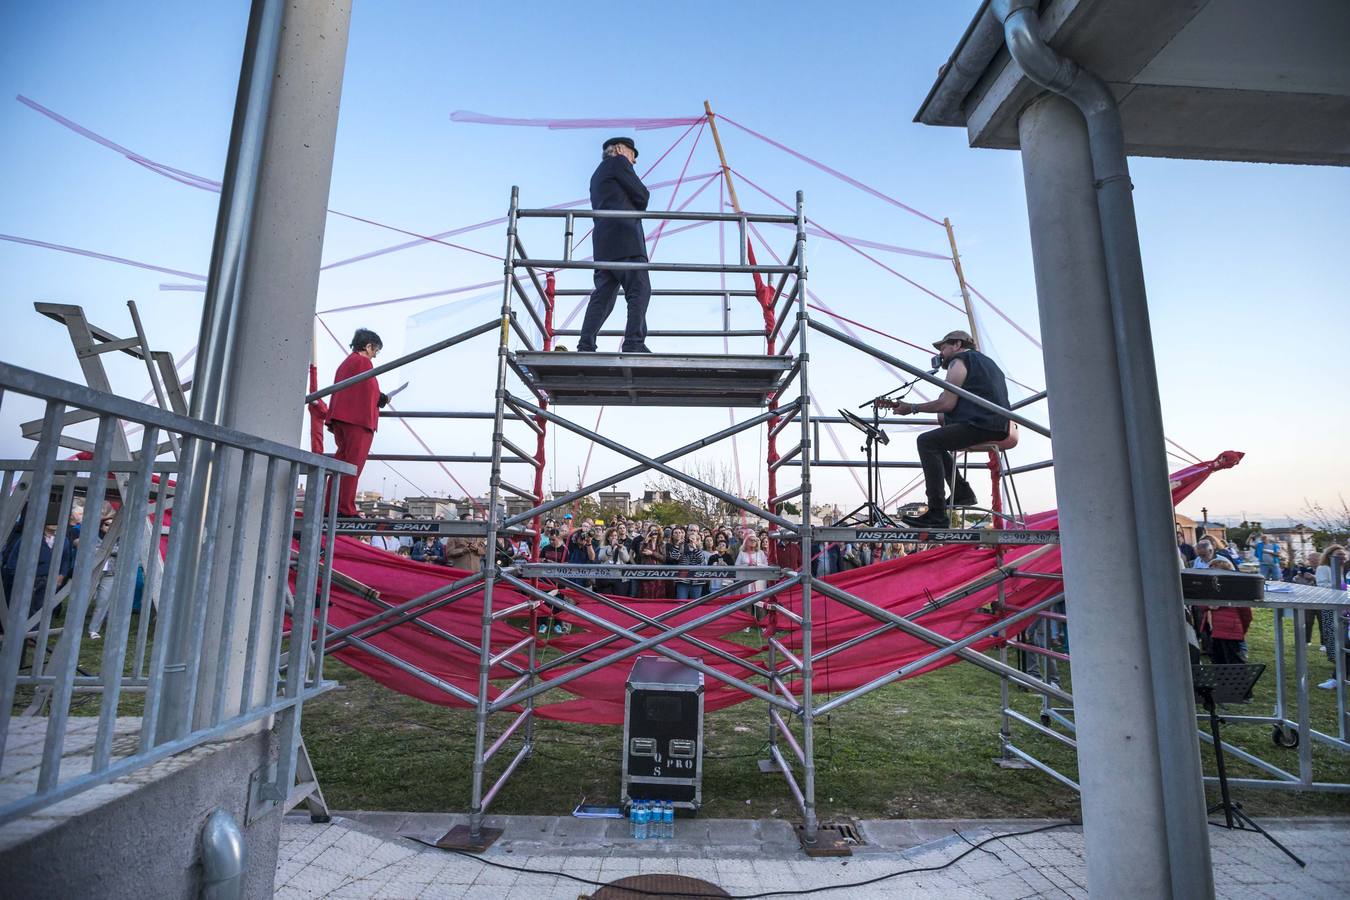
[914,0,1350,166]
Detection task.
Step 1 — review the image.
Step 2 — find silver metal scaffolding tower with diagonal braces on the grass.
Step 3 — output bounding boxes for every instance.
[284,188,1072,853]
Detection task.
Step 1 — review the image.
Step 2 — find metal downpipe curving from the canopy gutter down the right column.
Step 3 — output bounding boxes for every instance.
[990,0,1214,897]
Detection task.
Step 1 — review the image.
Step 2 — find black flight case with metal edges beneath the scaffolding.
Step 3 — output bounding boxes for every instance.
[622,656,703,812]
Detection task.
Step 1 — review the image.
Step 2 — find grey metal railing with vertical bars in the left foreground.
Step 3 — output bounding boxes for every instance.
[0,363,355,823]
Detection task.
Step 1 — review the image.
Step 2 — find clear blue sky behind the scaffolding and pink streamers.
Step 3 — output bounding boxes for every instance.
[0,0,1350,519]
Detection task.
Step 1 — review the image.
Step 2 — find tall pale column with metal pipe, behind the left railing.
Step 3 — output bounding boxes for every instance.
[157,0,351,741]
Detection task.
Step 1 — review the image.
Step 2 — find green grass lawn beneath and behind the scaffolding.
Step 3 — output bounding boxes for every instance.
[304,611,1350,818]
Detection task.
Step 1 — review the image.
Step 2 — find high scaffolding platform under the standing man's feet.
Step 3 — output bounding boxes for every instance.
[508,351,794,407]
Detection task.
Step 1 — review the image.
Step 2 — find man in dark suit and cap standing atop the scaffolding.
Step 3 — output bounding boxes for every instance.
[576,138,652,354]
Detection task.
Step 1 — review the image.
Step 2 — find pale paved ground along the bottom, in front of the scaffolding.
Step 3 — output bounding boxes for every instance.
[275,814,1350,900]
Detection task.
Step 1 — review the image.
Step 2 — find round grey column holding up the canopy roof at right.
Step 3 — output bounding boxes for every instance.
[1019,96,1214,897]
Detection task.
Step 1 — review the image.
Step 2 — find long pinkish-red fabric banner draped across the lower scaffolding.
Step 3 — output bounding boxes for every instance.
[309,451,1242,725]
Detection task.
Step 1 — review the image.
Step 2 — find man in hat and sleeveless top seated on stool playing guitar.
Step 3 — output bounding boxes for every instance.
[887,331,1008,528]
